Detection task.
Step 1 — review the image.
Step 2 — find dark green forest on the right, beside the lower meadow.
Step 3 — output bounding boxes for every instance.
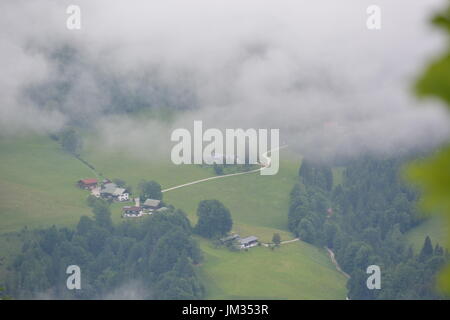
[289,158,448,299]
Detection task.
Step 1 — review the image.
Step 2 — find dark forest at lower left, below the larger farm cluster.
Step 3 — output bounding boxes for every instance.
[3,200,204,299]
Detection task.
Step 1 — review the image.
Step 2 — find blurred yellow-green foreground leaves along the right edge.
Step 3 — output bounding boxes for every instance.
[408,5,450,294]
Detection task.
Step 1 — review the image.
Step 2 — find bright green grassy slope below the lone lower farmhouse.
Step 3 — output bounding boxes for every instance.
[200,240,346,299]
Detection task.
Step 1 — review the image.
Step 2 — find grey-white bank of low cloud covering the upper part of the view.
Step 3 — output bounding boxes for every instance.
[0,0,449,157]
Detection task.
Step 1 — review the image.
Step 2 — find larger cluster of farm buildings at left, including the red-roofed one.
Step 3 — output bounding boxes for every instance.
[78,179,167,217]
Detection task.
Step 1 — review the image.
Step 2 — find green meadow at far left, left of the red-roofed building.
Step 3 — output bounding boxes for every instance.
[0,137,92,233]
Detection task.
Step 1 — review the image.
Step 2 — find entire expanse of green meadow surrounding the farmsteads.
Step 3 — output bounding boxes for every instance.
[0,137,346,299]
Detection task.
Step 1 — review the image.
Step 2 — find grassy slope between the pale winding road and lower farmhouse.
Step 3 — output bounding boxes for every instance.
[164,154,298,230]
